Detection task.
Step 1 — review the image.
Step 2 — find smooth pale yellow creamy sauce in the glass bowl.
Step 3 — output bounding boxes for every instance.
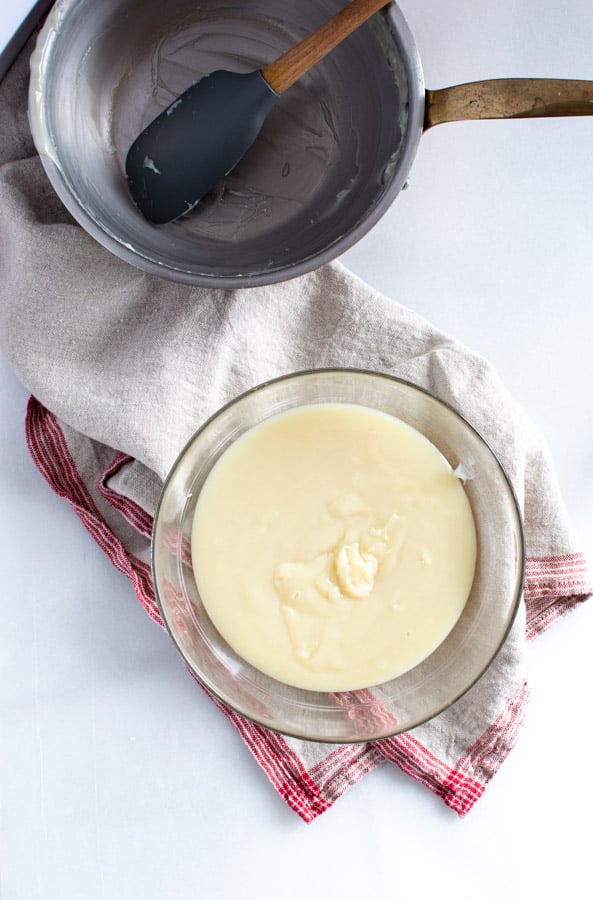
[192,404,476,691]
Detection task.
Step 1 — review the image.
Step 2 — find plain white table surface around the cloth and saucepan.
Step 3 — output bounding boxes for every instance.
[0,0,593,900]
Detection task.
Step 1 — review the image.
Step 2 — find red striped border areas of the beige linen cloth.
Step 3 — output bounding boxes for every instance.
[26,398,591,822]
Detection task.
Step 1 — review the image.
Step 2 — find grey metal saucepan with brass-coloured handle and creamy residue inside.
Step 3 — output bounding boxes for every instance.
[29,0,593,288]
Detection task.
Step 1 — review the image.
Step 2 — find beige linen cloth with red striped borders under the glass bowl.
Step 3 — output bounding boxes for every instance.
[0,47,592,821]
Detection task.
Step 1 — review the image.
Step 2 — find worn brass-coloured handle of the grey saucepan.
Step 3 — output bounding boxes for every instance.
[424,78,593,131]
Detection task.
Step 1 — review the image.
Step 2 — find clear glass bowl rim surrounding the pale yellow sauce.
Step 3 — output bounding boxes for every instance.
[152,369,524,743]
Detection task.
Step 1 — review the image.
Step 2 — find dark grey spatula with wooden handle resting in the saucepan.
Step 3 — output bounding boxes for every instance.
[126,0,387,225]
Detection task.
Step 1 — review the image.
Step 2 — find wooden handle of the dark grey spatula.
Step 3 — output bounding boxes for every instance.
[262,0,391,94]
